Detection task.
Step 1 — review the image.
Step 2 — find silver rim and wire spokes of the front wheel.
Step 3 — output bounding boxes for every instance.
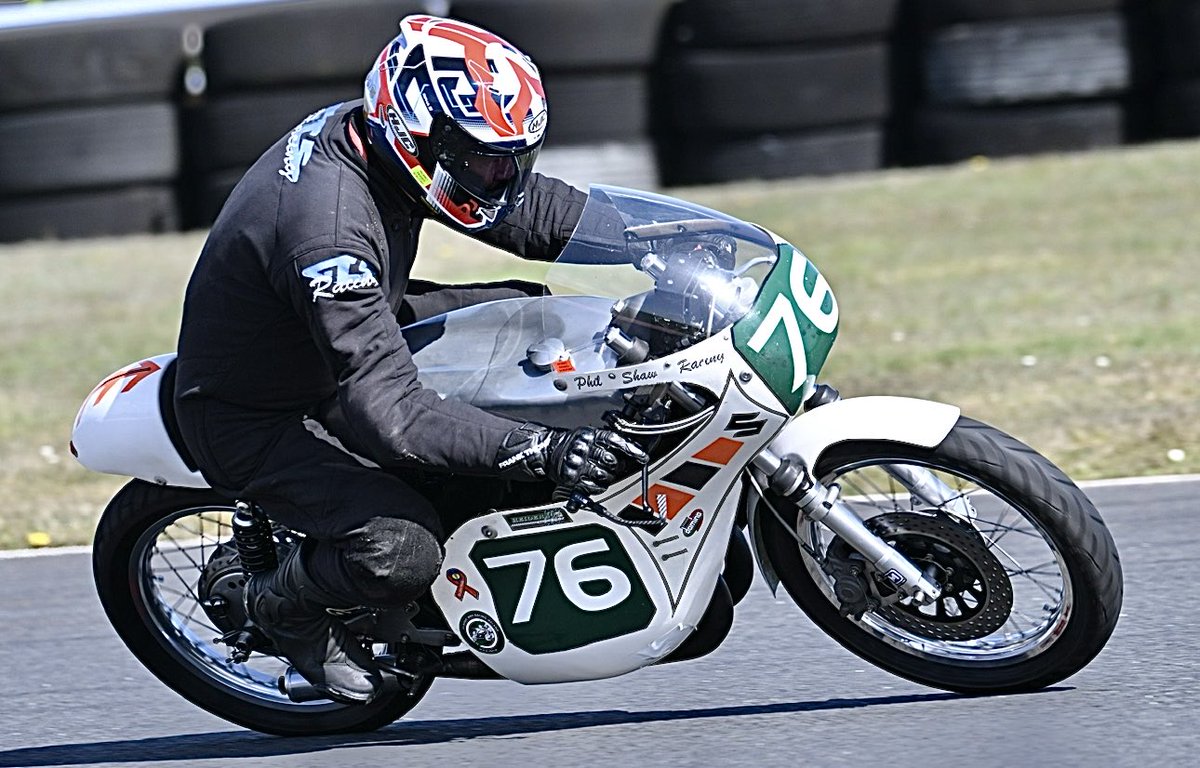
[797,458,1074,662]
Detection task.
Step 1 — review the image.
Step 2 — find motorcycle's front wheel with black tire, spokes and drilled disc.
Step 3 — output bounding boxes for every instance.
[762,418,1123,694]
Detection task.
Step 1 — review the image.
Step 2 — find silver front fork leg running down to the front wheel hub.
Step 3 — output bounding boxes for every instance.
[754,449,942,605]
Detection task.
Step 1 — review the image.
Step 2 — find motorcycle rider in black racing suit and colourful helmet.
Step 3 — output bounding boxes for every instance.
[175,16,646,703]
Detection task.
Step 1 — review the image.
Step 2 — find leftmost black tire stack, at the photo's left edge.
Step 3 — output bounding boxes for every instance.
[0,24,184,240]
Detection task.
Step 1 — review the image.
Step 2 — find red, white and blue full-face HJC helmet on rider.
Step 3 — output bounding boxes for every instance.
[362,16,546,230]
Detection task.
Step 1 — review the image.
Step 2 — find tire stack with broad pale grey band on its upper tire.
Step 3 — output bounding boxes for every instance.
[906,0,1133,164]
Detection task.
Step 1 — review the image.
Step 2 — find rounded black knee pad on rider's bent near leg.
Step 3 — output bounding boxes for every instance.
[346,517,442,607]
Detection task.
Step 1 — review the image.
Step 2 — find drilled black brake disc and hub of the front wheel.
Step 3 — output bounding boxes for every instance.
[828,512,1013,641]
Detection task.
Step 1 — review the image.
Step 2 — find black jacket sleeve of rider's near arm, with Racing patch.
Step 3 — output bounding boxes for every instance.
[274,247,517,472]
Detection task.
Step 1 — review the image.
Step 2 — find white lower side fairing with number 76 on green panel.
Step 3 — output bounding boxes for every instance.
[432,345,786,683]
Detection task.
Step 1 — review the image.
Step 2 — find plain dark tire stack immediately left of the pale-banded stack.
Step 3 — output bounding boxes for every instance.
[655,0,898,185]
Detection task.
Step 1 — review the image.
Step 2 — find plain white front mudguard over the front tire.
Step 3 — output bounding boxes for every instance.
[743,396,960,594]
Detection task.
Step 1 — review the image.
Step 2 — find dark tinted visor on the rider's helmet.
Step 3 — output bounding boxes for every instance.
[433,120,539,205]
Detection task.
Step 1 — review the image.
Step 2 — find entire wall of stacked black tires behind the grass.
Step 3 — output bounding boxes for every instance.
[0,0,1200,241]
